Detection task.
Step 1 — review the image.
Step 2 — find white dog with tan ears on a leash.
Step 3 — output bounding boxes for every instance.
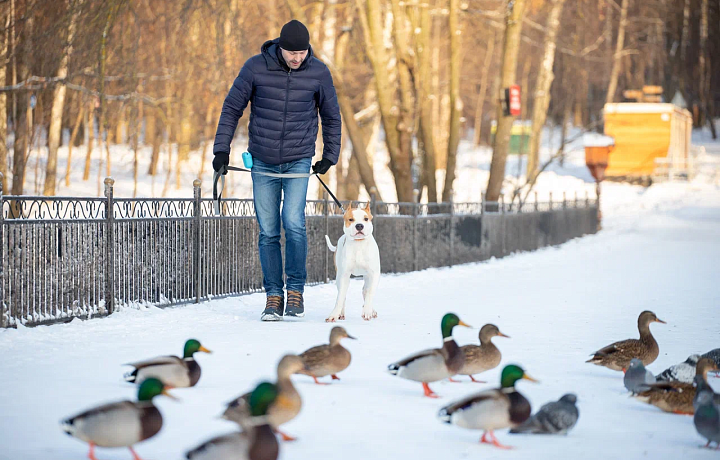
[325,203,380,323]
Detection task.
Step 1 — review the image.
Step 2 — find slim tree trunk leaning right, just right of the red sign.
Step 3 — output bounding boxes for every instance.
[527,0,565,182]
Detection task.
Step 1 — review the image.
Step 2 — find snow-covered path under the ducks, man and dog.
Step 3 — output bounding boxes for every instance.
[0,181,720,460]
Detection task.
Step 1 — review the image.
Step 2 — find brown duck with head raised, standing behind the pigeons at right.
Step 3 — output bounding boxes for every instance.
[586,310,667,372]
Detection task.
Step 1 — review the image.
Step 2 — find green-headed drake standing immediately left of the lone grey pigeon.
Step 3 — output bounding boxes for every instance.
[438,364,536,449]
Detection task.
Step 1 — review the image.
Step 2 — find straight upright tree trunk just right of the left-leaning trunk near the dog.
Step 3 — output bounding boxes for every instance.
[417,3,438,203]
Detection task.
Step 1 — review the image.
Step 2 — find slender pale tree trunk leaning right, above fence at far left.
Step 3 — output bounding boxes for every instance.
[43,1,78,196]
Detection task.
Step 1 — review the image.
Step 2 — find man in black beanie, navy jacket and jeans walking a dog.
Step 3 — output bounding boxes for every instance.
[213,20,341,321]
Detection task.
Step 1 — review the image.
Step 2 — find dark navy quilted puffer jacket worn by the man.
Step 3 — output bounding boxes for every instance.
[213,38,341,164]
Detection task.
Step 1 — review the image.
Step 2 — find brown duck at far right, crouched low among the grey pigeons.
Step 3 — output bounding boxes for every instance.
[635,358,718,415]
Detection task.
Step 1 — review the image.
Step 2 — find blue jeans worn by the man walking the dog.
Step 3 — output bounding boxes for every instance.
[252,158,312,295]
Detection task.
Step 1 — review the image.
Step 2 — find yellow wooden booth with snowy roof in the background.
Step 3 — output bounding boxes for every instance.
[604,102,692,180]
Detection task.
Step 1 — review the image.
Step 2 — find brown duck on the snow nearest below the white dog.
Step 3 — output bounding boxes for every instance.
[299,326,355,385]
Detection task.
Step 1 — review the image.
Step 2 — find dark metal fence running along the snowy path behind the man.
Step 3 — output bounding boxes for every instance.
[0,174,598,327]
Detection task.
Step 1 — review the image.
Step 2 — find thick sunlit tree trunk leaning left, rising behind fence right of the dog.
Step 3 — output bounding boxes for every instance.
[355,0,413,202]
